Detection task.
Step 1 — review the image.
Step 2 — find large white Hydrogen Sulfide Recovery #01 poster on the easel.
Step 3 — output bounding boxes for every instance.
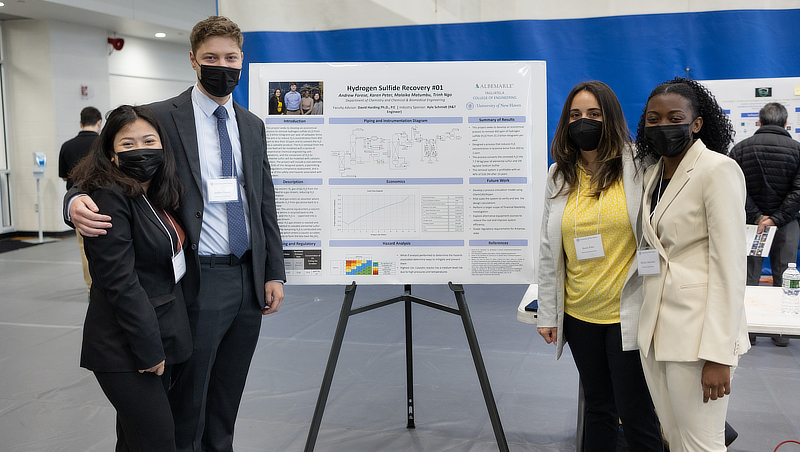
[249,62,547,284]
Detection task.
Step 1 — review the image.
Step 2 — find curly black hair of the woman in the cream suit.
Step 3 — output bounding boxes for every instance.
[636,77,734,161]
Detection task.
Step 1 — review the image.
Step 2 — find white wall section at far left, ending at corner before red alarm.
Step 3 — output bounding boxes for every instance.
[3,20,109,231]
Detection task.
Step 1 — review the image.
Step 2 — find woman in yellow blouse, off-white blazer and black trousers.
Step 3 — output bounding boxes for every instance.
[538,81,663,451]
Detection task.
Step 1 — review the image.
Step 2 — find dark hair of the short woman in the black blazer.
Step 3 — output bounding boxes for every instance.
[70,105,183,210]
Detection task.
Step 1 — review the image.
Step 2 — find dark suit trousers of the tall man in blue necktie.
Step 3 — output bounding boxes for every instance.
[169,261,263,452]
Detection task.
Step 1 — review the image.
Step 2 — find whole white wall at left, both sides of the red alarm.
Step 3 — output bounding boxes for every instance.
[0,20,196,232]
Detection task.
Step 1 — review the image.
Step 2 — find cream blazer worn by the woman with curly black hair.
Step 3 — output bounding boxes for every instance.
[639,140,750,366]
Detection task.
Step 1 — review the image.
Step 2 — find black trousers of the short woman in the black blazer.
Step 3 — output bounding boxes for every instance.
[94,366,175,452]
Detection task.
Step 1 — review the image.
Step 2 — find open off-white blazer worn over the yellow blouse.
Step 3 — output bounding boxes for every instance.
[537,147,642,359]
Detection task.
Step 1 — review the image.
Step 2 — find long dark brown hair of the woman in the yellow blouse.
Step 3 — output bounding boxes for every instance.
[550,80,631,198]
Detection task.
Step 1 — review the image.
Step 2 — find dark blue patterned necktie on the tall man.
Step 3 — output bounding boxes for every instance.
[214,105,248,258]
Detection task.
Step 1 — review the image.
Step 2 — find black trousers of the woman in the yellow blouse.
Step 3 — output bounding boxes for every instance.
[563,315,664,452]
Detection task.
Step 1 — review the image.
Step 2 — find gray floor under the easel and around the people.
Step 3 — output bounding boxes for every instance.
[0,238,800,452]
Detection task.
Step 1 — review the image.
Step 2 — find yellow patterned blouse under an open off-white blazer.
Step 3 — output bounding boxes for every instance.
[561,169,636,324]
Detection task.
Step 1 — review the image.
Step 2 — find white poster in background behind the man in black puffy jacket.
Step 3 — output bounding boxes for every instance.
[702,77,800,144]
